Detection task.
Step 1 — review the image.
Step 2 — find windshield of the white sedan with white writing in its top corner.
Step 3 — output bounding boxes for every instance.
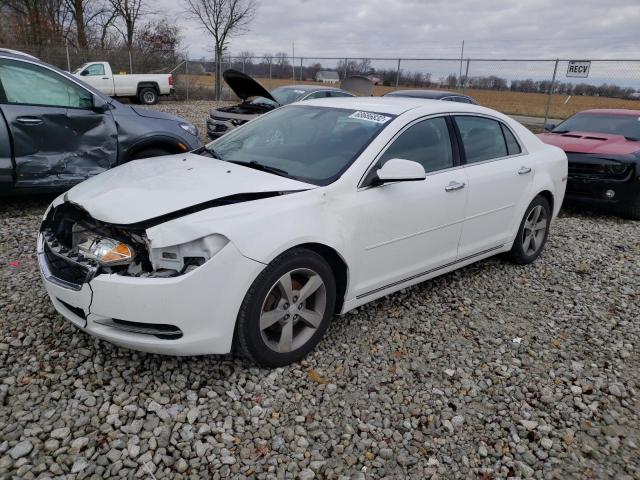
[205,105,393,185]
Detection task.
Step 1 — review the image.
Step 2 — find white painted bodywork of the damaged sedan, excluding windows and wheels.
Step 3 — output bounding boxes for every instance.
[40,98,567,355]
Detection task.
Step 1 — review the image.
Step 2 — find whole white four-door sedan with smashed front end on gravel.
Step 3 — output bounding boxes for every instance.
[38,97,567,367]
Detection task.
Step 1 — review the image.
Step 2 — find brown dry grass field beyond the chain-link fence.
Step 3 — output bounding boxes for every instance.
[178,75,640,118]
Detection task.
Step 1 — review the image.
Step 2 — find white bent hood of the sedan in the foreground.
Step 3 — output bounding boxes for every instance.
[66,153,315,225]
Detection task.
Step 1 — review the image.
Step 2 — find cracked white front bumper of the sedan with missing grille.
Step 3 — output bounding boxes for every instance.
[38,207,264,355]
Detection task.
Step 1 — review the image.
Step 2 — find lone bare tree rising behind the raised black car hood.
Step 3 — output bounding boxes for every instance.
[183,0,256,100]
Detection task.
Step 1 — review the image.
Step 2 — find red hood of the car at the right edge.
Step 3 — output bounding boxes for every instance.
[538,132,640,155]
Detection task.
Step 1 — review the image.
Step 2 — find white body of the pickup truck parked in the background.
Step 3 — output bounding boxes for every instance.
[74,62,172,97]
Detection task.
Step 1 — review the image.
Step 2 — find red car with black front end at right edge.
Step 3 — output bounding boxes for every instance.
[538,109,640,220]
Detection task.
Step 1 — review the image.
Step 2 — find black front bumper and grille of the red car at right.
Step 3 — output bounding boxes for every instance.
[565,153,640,209]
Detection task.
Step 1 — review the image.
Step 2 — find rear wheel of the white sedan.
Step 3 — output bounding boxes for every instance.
[509,195,551,265]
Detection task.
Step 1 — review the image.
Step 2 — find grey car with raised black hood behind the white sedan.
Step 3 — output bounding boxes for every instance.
[207,69,360,140]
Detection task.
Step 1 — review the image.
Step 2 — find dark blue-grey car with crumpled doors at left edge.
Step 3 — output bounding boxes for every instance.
[0,49,202,194]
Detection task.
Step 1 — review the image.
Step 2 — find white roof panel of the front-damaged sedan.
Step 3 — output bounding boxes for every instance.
[304,97,492,118]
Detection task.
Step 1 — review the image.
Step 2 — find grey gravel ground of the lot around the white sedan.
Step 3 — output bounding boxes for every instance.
[0,103,640,479]
